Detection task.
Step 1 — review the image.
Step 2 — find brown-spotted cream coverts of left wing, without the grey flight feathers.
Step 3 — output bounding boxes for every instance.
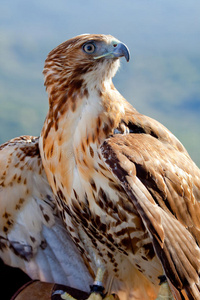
[0,136,55,261]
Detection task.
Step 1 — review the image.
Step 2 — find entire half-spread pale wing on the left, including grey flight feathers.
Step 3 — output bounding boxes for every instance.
[0,136,92,291]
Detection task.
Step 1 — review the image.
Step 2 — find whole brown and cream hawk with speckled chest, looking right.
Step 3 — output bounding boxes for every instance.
[0,34,200,300]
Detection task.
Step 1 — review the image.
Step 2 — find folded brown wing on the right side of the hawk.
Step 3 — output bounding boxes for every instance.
[101,134,200,299]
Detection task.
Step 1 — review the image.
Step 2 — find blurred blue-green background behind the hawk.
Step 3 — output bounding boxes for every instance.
[0,0,200,166]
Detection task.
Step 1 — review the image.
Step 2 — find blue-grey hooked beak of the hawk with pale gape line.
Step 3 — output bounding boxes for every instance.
[94,42,130,62]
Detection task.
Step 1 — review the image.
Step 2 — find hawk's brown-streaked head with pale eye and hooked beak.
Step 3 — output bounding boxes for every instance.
[43,34,129,97]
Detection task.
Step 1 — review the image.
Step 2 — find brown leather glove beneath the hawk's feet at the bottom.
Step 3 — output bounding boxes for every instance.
[11,280,89,300]
